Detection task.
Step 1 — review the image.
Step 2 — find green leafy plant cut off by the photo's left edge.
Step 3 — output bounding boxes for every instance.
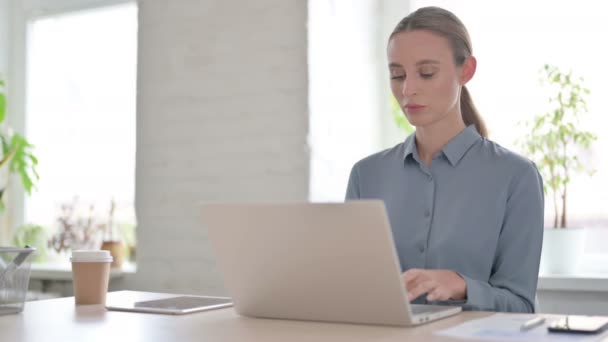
[0,78,38,212]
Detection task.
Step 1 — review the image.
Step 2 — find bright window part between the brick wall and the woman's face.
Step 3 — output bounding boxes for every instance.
[308,0,407,201]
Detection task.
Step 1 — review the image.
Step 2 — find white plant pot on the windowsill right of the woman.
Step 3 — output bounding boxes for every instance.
[540,228,585,274]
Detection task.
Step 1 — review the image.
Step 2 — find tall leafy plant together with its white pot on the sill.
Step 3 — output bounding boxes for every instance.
[519,65,596,273]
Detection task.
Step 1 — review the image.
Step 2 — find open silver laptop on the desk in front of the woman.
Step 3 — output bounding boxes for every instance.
[201,200,462,326]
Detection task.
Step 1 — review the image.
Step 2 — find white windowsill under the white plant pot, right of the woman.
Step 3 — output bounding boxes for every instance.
[538,273,608,292]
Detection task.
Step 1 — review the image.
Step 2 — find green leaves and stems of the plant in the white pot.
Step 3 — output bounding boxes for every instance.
[518,65,597,227]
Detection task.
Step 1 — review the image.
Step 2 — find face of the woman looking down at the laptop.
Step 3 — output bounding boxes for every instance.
[388,30,475,127]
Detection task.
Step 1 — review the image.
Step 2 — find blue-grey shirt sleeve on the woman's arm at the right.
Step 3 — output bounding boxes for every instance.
[461,164,544,312]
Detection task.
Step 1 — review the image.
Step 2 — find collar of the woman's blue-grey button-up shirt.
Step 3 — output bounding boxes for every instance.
[403,125,481,166]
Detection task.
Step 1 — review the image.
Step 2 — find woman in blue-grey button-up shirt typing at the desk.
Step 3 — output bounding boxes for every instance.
[346,7,544,312]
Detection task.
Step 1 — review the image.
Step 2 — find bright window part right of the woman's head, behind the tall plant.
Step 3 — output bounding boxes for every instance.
[412,0,608,271]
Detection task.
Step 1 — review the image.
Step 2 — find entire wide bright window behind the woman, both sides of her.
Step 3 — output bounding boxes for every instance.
[309,0,608,272]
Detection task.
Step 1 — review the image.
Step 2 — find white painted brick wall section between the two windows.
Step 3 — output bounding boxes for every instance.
[125,0,309,293]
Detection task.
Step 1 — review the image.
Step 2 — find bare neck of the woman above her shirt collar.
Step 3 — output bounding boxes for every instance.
[416,113,466,167]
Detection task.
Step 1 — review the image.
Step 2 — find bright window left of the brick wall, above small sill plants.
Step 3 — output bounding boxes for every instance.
[19,3,137,260]
